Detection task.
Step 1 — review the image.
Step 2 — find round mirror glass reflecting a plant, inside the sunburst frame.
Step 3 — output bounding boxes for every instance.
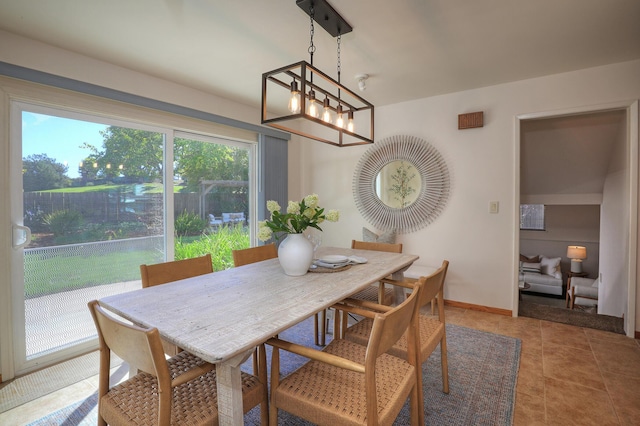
[376,160,422,209]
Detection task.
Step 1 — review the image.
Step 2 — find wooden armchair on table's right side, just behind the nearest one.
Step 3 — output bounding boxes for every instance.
[344,260,449,421]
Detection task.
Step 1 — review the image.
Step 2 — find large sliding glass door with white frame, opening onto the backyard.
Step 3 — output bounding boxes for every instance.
[5,102,256,377]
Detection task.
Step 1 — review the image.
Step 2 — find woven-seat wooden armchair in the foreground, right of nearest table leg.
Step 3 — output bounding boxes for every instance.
[267,282,421,426]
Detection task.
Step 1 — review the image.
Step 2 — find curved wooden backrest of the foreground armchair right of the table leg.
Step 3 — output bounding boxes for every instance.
[365,284,420,362]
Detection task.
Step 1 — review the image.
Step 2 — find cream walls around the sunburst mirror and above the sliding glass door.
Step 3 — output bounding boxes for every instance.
[0,32,640,332]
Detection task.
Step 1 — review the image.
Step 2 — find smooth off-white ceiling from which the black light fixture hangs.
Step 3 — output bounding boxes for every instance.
[0,0,640,110]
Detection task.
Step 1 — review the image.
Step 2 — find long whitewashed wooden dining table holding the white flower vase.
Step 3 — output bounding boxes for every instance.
[99,247,418,425]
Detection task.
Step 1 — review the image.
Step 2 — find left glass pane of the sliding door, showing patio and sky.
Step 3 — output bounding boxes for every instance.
[22,111,165,360]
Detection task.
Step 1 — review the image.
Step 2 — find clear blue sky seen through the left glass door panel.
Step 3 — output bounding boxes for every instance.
[22,111,108,178]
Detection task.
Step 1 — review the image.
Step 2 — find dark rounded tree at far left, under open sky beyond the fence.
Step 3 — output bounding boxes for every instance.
[22,154,71,192]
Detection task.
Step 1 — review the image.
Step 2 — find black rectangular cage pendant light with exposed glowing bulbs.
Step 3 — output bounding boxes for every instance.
[262,0,374,147]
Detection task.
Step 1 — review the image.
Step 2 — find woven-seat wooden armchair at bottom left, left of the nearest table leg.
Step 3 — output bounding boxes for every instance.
[89,300,269,426]
